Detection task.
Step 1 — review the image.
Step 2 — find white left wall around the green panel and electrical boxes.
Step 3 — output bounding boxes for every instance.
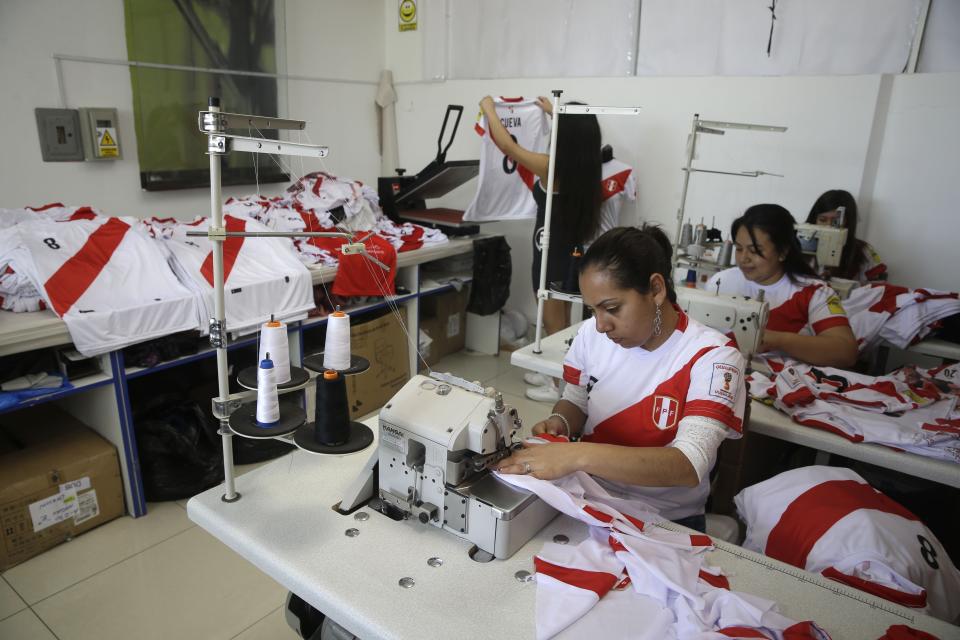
[0,0,384,217]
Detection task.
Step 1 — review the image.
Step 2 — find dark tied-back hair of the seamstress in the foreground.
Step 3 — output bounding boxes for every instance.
[580,224,677,302]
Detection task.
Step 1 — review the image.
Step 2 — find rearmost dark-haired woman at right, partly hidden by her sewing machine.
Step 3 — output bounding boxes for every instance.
[807,189,887,284]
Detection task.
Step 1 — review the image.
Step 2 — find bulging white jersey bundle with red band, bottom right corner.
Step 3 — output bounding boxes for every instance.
[734,466,960,622]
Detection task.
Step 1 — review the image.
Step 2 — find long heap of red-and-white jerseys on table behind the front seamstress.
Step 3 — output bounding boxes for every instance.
[749,357,960,463]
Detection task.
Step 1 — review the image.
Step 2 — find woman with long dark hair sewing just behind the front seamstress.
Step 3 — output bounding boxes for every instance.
[707,204,858,368]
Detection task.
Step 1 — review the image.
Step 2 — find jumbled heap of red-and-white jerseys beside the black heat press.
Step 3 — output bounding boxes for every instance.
[224,172,447,267]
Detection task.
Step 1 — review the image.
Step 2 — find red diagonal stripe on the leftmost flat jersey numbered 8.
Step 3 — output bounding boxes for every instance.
[43,218,130,317]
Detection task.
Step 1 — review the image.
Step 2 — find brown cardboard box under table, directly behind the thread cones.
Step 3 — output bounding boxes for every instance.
[347,308,410,419]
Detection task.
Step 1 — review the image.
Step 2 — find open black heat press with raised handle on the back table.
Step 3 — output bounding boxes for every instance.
[377,104,480,236]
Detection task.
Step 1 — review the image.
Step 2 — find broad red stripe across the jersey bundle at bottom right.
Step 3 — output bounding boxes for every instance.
[764,480,918,569]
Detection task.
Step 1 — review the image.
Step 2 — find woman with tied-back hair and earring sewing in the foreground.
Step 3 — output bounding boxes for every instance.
[499,227,746,531]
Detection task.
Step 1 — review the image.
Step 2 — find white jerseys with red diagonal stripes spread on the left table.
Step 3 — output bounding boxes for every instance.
[0,204,313,356]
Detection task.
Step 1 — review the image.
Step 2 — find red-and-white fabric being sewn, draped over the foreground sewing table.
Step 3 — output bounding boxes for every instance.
[499,472,829,640]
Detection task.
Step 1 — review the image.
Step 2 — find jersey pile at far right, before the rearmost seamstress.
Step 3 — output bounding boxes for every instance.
[843,282,960,351]
